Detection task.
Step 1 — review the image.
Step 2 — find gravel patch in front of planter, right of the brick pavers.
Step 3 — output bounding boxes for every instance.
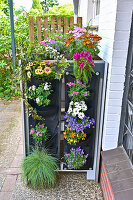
[11,173,103,200]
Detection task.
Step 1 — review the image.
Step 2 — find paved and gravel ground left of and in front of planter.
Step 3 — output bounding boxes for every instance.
[0,101,103,200]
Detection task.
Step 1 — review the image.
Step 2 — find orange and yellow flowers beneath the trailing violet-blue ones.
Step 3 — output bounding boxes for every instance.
[64,127,86,144]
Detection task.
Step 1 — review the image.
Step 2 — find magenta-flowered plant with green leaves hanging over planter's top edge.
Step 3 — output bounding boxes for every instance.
[73,50,94,84]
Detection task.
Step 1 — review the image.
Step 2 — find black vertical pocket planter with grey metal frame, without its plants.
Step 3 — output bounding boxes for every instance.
[22,61,107,180]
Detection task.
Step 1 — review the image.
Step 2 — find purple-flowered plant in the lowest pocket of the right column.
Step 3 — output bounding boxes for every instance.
[64,147,88,169]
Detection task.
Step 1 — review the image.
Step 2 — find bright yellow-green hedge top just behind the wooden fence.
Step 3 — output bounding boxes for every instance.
[45,4,74,17]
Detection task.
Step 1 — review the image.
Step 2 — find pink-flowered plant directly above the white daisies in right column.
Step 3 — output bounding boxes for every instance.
[66,79,90,102]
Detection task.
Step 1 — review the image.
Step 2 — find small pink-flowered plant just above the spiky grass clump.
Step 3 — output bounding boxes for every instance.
[30,123,49,144]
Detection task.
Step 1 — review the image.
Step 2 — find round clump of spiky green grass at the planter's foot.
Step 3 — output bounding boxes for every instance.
[22,149,58,189]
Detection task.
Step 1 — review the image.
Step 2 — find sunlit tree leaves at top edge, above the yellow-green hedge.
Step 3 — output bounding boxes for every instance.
[41,0,59,13]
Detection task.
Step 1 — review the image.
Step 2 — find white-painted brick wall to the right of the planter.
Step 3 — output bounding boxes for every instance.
[98,0,133,150]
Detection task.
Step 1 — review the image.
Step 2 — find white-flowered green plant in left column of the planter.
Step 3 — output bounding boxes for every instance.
[26,82,53,106]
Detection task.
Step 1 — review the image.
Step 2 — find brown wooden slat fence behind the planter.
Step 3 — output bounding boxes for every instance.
[29,16,82,42]
